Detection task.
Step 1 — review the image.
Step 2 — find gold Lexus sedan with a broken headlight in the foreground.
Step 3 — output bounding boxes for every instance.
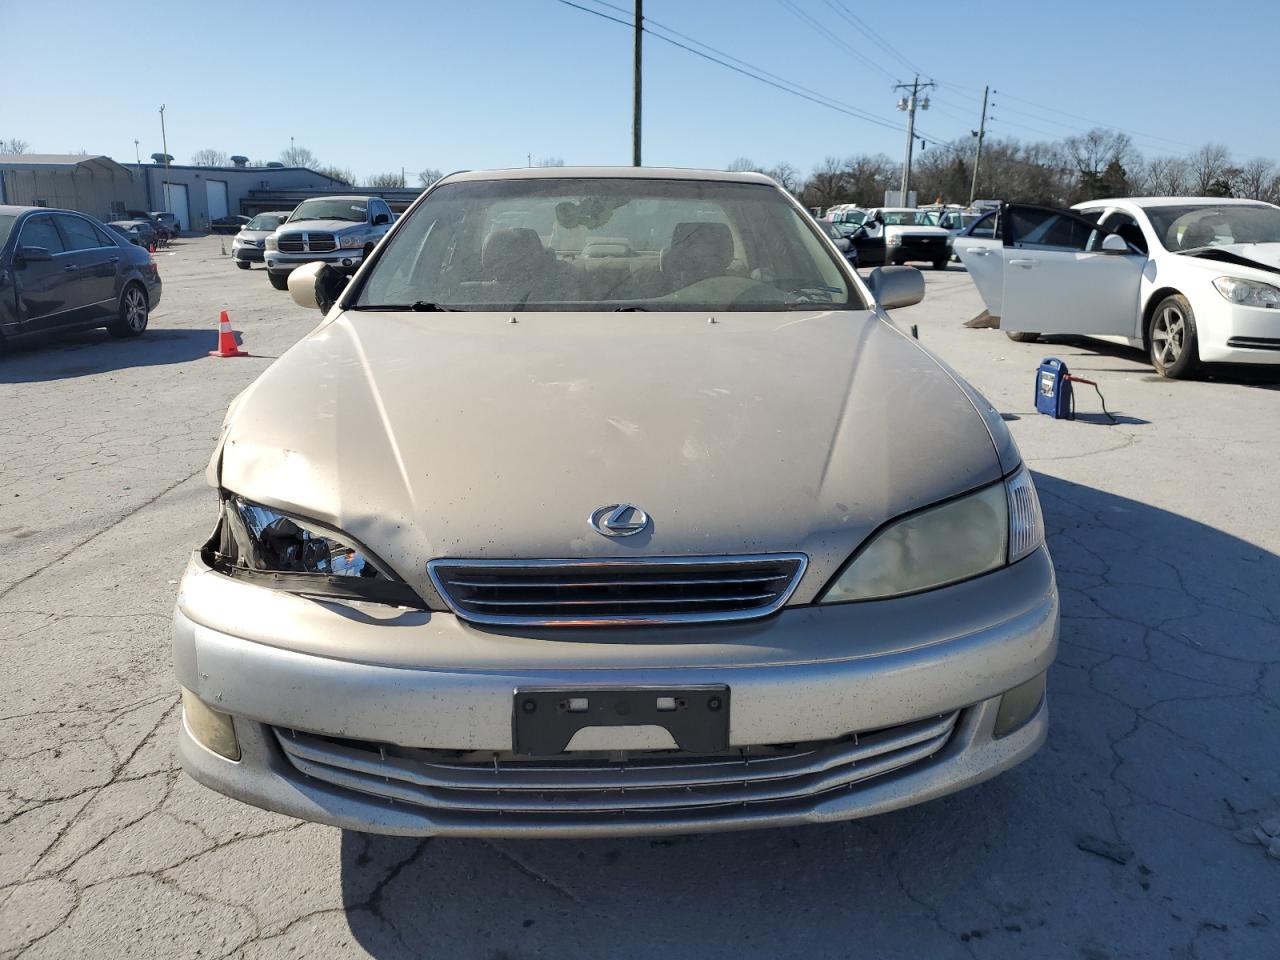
[174,168,1059,836]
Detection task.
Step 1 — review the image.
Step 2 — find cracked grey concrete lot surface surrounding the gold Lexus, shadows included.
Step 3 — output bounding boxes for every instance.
[0,237,1280,960]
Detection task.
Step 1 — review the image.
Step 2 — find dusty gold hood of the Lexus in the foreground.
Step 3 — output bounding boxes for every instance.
[211,311,1001,603]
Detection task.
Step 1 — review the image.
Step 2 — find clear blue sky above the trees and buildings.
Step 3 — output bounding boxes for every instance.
[0,0,1280,175]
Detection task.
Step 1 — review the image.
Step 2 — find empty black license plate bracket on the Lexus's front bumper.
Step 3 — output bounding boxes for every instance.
[511,685,730,756]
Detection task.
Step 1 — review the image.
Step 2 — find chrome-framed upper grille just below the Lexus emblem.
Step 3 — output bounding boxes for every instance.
[428,553,806,626]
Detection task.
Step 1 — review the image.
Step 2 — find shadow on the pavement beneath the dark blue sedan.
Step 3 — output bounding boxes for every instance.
[0,328,218,384]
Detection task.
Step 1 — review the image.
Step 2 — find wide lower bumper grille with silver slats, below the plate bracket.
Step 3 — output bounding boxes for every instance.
[274,712,960,819]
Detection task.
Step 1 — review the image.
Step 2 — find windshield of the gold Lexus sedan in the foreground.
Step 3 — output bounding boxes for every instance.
[355,178,863,311]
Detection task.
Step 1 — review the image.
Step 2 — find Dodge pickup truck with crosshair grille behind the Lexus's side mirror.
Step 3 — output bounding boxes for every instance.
[265,196,396,291]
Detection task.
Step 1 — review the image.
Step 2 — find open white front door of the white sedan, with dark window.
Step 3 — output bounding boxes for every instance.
[1000,204,1147,337]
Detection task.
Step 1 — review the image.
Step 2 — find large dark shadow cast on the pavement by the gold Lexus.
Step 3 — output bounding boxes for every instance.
[342,475,1280,960]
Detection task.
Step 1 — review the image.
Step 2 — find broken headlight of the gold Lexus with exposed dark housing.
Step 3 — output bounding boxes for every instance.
[210,495,422,607]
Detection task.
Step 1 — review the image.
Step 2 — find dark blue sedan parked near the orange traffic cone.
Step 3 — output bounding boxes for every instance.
[0,206,160,352]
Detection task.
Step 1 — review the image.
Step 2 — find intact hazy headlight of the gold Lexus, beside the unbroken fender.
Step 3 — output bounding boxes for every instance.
[819,467,1044,603]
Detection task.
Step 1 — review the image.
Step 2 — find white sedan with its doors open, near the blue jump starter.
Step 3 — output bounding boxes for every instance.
[955,197,1280,378]
